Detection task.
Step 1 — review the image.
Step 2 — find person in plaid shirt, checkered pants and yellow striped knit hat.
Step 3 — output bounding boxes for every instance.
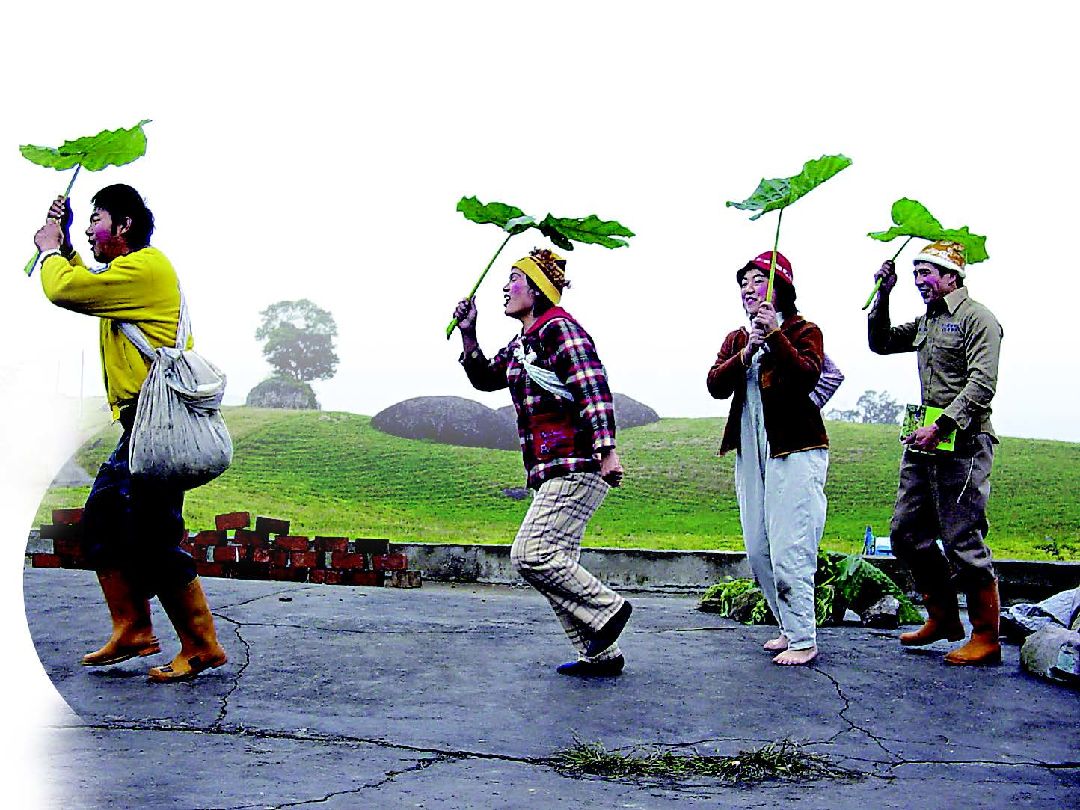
[454,249,633,677]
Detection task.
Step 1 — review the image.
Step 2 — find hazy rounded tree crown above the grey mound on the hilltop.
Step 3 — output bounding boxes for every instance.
[255,298,338,382]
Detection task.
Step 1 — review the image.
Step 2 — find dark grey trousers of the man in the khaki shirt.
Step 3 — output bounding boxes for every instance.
[890,433,995,593]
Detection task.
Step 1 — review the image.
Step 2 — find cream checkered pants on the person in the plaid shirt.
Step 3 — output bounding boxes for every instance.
[510,473,625,661]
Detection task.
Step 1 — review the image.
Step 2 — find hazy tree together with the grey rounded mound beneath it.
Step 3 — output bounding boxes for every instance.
[247,298,338,410]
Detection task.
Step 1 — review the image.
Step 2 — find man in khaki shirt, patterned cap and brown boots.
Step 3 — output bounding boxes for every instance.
[868,242,1002,664]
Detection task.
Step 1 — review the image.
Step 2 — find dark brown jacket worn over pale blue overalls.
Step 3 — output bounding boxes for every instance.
[707,315,828,458]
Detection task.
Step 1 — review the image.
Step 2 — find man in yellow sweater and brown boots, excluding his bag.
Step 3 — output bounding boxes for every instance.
[33,185,227,683]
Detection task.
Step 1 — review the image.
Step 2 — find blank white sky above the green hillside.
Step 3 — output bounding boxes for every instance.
[0,0,1080,804]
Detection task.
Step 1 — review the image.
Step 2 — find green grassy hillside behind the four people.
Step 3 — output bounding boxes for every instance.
[38,407,1080,559]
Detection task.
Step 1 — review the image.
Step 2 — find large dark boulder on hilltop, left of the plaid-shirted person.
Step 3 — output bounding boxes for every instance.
[372,396,519,450]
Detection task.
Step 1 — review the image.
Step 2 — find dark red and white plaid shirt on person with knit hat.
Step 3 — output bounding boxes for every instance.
[460,307,615,489]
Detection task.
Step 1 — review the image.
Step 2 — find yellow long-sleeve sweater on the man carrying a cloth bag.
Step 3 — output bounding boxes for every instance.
[41,247,194,418]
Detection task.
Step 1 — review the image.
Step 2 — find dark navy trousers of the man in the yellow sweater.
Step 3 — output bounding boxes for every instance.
[82,408,195,597]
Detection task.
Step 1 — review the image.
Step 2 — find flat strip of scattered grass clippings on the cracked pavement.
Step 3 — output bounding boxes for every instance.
[552,740,862,784]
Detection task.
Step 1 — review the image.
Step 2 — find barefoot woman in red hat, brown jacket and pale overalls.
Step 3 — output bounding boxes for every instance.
[707,251,828,666]
